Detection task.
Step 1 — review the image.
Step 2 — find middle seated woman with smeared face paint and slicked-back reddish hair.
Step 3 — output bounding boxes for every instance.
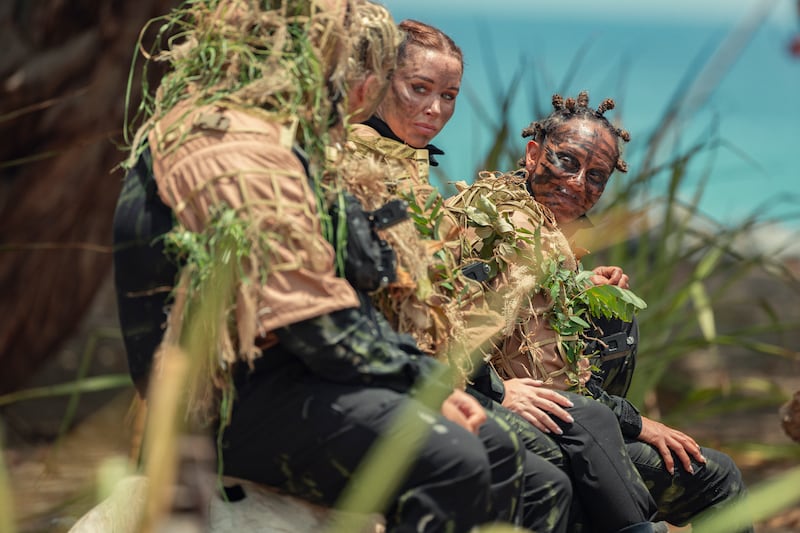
[348,21,676,532]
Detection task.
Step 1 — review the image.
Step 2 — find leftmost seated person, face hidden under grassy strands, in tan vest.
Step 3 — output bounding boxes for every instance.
[114,0,552,532]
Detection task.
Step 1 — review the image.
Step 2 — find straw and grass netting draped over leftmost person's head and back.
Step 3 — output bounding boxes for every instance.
[121,0,400,421]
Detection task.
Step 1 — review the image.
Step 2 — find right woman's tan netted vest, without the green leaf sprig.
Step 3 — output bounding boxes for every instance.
[448,173,589,390]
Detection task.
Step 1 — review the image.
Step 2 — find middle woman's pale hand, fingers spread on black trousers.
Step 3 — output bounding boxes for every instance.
[503,378,573,435]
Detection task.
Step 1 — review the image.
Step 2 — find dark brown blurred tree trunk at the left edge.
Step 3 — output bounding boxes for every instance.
[0,0,177,394]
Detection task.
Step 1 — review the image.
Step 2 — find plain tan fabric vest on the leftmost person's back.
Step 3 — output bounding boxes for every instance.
[148,98,358,366]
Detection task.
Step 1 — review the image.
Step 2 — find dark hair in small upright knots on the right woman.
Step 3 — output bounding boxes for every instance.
[519,91,631,172]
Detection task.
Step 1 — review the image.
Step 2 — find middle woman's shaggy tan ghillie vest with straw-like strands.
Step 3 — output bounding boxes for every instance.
[345,124,500,386]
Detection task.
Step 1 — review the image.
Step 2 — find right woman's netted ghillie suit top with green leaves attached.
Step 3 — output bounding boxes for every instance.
[447,171,644,390]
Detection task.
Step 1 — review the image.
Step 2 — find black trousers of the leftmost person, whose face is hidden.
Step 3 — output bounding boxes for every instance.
[222,360,572,533]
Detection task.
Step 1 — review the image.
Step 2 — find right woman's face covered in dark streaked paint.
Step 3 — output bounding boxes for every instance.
[527,119,619,224]
